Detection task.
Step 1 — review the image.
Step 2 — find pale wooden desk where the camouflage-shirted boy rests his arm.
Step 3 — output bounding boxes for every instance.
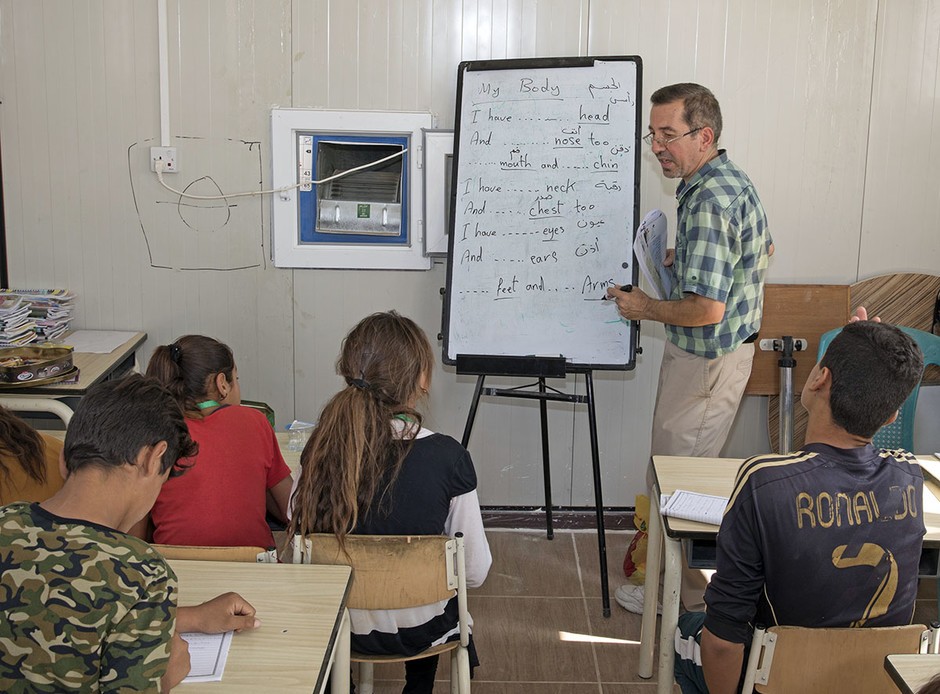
[169,559,351,694]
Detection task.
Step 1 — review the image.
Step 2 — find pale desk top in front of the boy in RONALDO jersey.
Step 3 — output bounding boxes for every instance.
[652,454,940,545]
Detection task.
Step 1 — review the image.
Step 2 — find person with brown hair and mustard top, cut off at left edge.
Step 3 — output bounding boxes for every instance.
[0,407,62,505]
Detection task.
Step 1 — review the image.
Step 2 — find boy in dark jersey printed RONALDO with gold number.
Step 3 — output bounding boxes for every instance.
[676,320,925,694]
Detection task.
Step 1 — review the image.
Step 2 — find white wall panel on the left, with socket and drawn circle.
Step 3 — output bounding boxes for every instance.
[0,1,293,424]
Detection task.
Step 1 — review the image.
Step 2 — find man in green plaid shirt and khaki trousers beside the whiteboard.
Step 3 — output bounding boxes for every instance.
[607,83,773,611]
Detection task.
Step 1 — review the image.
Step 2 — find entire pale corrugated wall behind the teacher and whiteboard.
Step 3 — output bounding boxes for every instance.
[0,0,940,505]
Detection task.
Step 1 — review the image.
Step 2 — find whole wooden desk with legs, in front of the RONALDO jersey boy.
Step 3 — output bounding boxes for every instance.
[638,456,940,694]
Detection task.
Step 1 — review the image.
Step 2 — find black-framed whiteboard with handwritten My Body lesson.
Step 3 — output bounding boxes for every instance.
[443,56,642,370]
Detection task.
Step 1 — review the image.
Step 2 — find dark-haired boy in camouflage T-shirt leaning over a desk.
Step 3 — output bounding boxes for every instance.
[0,374,259,692]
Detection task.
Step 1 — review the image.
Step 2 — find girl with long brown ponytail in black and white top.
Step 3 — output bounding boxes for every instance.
[290,311,492,692]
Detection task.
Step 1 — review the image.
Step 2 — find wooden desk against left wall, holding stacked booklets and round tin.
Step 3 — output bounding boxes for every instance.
[0,332,147,426]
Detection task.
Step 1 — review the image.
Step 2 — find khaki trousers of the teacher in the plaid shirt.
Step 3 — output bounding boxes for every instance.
[651,340,754,612]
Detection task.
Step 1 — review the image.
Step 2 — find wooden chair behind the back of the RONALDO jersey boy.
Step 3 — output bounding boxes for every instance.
[741,624,932,694]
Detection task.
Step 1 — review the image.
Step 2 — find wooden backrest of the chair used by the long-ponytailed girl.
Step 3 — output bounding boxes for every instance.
[294,533,458,610]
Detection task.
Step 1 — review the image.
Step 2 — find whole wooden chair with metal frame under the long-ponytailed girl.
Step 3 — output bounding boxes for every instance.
[294,533,470,694]
